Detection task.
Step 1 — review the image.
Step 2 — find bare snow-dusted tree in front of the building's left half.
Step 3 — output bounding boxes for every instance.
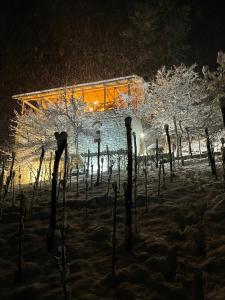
[11,96,90,161]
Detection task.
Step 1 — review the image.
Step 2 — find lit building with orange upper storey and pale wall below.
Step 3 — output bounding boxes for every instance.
[12,75,145,183]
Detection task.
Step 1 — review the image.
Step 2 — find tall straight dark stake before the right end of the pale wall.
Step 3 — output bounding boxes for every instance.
[125,117,133,251]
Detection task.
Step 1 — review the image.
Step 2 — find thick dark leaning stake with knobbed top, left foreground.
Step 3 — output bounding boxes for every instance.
[47,132,67,251]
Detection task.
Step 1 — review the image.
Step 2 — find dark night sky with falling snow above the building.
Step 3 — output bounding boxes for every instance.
[0,0,225,143]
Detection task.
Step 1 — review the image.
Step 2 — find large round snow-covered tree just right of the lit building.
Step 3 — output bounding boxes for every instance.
[141,65,221,137]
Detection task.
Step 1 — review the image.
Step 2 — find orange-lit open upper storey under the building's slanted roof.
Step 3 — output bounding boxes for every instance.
[12,75,144,111]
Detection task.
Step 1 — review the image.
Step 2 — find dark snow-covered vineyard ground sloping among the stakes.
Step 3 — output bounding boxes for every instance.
[0,158,225,300]
